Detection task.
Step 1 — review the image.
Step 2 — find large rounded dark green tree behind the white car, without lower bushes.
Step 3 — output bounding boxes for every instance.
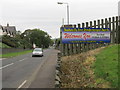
[21,29,51,48]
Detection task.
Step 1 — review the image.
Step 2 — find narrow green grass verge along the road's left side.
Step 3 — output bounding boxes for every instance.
[0,50,32,58]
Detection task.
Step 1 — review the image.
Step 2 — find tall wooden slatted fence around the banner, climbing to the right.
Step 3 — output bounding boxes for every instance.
[60,16,120,56]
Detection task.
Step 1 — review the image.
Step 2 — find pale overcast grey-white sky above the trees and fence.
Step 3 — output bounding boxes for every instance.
[0,0,120,38]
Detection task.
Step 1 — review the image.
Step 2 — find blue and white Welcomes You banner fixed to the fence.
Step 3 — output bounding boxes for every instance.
[61,28,110,44]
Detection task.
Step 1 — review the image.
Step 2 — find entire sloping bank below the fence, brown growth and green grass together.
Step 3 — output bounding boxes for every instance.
[60,45,118,88]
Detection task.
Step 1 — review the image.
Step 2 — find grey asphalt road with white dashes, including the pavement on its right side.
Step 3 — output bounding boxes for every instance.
[0,49,58,89]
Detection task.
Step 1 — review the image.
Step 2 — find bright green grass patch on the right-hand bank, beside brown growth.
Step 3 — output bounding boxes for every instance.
[94,45,118,87]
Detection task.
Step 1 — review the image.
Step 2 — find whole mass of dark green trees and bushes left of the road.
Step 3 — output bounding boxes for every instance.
[2,29,52,49]
